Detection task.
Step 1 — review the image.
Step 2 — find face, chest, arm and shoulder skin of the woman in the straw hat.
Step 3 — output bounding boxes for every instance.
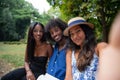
[65,26,107,80]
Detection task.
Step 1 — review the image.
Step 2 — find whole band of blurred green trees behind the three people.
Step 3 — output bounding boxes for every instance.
[0,0,120,42]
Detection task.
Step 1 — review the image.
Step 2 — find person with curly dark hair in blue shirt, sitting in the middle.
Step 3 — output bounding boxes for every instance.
[37,18,67,80]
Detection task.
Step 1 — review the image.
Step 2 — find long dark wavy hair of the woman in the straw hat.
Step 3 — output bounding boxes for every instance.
[69,24,96,71]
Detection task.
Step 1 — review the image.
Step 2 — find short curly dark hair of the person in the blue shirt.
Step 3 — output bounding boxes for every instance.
[45,18,67,42]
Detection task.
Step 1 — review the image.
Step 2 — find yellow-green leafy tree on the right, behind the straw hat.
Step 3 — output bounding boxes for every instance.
[47,0,120,41]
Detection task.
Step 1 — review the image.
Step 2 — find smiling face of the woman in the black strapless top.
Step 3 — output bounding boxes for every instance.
[33,24,43,41]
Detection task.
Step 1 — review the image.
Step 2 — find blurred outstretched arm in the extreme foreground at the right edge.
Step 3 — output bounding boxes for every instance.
[97,13,120,80]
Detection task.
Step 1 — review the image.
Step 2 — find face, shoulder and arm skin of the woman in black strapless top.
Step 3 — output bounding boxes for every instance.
[25,25,52,80]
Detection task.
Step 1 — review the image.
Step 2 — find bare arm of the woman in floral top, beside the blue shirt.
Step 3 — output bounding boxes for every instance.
[65,50,72,80]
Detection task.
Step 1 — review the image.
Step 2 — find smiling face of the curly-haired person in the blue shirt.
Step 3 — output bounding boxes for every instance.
[50,27,63,42]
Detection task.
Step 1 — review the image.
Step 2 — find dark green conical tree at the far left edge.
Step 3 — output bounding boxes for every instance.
[0,8,18,40]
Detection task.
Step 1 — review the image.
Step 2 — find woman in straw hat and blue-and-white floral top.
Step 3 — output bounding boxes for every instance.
[64,17,106,80]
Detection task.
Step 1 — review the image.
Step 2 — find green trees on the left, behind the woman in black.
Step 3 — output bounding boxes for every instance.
[0,0,50,41]
